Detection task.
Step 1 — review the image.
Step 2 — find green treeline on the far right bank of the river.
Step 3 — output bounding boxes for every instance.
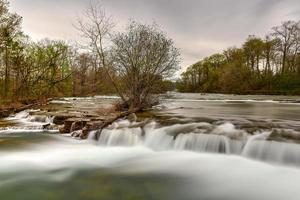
[177,21,300,95]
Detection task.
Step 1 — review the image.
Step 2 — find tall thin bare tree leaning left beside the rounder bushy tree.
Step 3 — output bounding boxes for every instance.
[76,2,126,101]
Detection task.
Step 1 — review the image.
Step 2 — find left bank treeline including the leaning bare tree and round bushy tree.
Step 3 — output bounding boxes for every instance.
[0,0,179,104]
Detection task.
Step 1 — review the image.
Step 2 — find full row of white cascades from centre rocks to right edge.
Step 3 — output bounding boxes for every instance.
[94,121,300,166]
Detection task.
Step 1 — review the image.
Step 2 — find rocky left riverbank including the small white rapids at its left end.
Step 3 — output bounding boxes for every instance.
[0,96,145,139]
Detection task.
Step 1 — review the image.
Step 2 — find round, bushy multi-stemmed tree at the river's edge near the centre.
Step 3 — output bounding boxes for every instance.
[111,21,180,108]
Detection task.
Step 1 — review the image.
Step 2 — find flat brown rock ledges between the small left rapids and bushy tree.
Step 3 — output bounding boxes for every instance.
[30,96,122,139]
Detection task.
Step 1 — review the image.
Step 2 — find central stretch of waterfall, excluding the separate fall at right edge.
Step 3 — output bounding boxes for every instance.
[95,122,244,154]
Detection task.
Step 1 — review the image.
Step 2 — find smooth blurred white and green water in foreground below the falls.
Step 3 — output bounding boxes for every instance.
[0,135,300,200]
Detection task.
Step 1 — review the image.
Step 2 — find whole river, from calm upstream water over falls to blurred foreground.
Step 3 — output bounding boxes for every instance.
[0,93,300,200]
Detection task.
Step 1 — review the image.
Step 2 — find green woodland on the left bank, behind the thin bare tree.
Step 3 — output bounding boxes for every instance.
[0,0,119,103]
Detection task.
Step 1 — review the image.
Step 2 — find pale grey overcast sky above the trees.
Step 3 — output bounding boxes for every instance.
[10,0,300,69]
